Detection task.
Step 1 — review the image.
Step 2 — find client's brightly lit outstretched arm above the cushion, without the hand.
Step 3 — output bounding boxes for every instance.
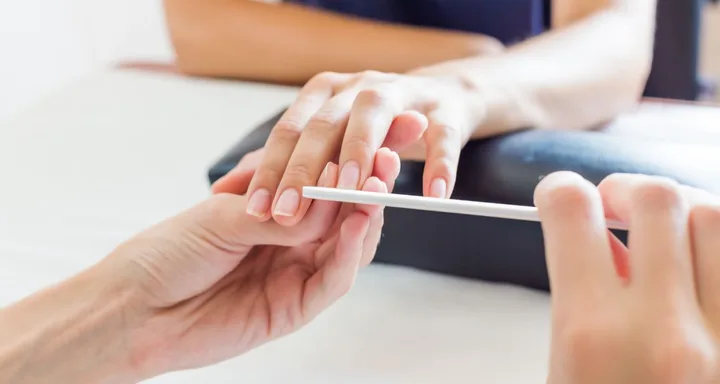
[414,0,656,138]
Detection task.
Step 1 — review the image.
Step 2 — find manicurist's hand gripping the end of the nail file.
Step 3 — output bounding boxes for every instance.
[535,173,720,384]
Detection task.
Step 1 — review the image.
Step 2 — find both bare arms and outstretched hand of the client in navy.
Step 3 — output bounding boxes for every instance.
[191,0,656,226]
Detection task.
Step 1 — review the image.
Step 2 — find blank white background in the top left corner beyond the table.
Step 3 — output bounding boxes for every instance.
[0,0,173,120]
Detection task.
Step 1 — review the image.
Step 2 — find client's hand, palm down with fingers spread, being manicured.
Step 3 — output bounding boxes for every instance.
[224,72,483,225]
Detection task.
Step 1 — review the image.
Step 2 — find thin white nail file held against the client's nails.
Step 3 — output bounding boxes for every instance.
[303,187,627,231]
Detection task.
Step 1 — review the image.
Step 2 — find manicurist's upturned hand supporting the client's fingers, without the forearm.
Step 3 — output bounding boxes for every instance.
[114,148,400,377]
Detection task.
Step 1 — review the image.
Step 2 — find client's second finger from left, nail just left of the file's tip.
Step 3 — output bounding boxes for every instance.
[273,91,355,226]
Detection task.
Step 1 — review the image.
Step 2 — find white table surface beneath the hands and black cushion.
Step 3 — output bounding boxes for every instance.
[0,71,549,384]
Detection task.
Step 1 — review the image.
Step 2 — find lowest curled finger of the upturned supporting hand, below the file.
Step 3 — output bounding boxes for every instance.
[303,208,370,319]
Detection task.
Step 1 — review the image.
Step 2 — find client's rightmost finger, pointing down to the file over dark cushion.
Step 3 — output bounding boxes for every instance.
[423,109,464,198]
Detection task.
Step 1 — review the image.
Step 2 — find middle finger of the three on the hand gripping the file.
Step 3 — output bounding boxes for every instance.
[624,176,696,305]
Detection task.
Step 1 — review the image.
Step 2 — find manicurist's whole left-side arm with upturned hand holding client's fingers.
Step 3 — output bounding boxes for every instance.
[0,157,400,384]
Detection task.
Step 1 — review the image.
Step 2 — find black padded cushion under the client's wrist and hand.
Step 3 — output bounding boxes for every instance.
[209,108,720,290]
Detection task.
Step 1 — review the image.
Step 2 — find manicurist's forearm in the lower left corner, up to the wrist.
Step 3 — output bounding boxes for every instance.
[0,260,142,384]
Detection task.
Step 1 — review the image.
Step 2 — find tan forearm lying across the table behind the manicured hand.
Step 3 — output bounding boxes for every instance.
[165,0,502,84]
